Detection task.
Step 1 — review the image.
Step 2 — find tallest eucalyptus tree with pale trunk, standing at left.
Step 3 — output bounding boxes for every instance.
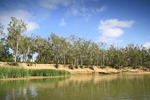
[8,17,27,62]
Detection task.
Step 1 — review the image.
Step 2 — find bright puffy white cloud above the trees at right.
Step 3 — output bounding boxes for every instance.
[98,19,134,43]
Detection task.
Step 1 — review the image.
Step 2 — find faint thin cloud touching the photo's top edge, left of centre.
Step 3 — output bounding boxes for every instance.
[39,0,71,9]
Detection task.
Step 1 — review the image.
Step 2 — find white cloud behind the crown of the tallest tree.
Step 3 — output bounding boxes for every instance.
[0,10,39,31]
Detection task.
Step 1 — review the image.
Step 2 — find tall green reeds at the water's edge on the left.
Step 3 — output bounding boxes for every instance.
[0,67,70,78]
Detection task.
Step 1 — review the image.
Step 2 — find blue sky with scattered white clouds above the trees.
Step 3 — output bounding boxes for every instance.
[0,0,150,48]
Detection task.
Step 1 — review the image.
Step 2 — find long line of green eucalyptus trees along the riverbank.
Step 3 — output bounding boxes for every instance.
[0,17,150,68]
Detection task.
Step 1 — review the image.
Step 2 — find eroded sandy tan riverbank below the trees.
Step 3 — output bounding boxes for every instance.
[0,62,150,74]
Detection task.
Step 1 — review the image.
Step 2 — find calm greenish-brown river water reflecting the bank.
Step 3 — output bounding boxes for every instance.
[0,74,150,100]
